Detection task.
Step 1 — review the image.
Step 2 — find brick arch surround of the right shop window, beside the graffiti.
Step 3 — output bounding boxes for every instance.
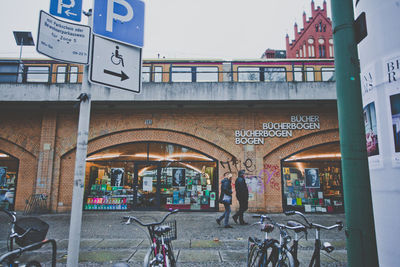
[263,129,339,212]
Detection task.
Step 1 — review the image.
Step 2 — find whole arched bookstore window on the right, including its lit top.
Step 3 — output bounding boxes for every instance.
[282,142,344,213]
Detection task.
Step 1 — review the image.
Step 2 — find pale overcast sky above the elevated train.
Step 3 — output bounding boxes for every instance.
[0,0,331,60]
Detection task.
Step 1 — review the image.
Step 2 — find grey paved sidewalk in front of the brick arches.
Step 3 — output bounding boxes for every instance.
[0,211,346,266]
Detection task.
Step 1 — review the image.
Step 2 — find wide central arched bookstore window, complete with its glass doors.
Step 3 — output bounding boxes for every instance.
[84,142,218,210]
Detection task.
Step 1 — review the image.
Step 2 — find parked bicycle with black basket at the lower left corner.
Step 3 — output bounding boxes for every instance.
[0,209,57,267]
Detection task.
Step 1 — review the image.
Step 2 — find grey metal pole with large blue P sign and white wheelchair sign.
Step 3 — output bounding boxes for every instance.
[65,0,144,267]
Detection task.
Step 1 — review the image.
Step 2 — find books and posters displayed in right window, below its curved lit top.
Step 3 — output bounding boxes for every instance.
[282,162,344,213]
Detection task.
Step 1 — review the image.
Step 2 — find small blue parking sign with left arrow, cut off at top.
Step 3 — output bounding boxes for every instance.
[50,0,82,22]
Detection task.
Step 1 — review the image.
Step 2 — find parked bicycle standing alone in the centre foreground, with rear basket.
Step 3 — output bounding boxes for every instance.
[124,210,179,267]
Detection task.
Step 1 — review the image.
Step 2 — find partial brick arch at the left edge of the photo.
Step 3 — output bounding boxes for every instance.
[0,138,37,210]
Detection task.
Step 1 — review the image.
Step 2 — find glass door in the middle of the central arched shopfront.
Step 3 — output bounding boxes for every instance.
[133,162,160,210]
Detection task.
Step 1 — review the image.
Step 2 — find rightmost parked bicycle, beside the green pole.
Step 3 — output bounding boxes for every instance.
[285,211,343,267]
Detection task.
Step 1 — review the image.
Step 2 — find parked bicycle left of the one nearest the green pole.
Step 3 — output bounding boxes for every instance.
[247,215,296,267]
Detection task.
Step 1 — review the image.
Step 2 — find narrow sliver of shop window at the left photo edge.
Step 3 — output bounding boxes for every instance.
[0,152,18,210]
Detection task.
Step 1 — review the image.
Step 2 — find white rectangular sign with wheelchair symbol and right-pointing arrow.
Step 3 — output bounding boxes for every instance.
[89,36,142,93]
